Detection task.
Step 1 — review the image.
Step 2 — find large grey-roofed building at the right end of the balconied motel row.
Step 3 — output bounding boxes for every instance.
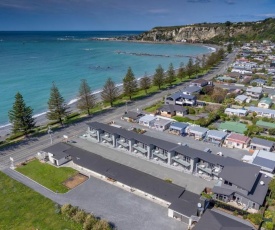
[212,158,271,210]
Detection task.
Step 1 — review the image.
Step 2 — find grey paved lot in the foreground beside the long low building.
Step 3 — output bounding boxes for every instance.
[64,174,187,230]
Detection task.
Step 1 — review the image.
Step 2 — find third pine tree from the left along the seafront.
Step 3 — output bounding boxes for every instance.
[77,79,96,115]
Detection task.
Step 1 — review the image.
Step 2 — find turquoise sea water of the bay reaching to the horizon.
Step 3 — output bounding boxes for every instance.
[0,31,211,126]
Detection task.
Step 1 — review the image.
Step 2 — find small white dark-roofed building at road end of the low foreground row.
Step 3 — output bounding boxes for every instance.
[40,142,71,166]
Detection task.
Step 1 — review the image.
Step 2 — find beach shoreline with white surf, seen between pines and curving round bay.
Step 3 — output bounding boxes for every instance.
[0,38,219,138]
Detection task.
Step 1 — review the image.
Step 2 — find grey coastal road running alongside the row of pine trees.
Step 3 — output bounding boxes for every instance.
[0,51,237,170]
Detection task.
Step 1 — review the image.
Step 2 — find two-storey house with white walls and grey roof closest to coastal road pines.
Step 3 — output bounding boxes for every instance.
[165,92,197,106]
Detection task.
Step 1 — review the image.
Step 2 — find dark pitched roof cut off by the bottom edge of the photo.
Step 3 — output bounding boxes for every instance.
[193,209,254,230]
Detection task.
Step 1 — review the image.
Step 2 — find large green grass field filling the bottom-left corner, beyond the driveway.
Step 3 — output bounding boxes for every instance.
[0,172,82,230]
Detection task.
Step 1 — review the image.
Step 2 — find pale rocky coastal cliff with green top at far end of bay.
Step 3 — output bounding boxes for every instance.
[136,18,275,43]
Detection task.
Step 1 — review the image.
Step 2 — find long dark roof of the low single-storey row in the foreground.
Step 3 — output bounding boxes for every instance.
[63,146,199,216]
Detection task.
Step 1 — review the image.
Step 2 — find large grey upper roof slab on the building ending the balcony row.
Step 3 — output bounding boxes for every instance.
[219,157,260,191]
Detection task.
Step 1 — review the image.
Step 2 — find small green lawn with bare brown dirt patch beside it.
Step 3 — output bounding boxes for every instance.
[16,160,77,193]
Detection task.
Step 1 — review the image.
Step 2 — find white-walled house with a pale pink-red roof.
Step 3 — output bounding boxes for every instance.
[223,133,251,149]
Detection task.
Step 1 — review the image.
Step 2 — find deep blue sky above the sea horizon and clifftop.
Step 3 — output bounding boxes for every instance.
[0,0,275,31]
